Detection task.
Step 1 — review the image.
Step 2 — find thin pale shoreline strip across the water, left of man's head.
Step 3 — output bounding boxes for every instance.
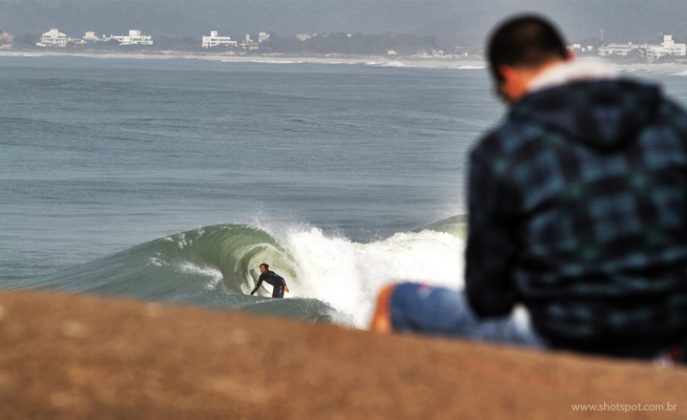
[0,50,486,70]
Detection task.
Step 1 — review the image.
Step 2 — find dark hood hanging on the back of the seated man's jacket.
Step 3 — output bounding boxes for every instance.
[511,79,661,150]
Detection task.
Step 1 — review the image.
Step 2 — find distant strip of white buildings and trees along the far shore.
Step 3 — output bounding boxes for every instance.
[0,28,687,63]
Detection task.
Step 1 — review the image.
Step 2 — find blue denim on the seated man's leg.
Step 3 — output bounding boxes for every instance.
[391,283,546,348]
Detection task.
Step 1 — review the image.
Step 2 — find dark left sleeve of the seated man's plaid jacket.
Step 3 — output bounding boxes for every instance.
[465,149,516,318]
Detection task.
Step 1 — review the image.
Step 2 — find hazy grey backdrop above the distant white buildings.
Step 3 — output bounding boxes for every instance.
[0,0,687,44]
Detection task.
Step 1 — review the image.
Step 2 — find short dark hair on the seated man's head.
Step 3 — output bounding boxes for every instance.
[487,15,568,83]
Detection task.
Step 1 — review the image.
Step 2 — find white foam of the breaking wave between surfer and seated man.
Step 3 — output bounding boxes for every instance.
[276,228,464,328]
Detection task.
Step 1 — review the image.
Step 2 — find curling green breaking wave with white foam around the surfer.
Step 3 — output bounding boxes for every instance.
[9,218,464,327]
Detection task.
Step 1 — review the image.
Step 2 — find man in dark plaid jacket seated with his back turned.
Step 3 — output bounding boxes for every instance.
[372,16,687,358]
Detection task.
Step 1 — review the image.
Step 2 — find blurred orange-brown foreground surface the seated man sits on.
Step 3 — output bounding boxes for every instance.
[0,293,687,420]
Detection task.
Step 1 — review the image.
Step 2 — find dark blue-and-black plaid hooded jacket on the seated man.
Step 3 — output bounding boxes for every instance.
[466,79,687,352]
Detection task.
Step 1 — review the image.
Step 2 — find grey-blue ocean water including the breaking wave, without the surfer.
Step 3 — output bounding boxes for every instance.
[0,57,687,326]
